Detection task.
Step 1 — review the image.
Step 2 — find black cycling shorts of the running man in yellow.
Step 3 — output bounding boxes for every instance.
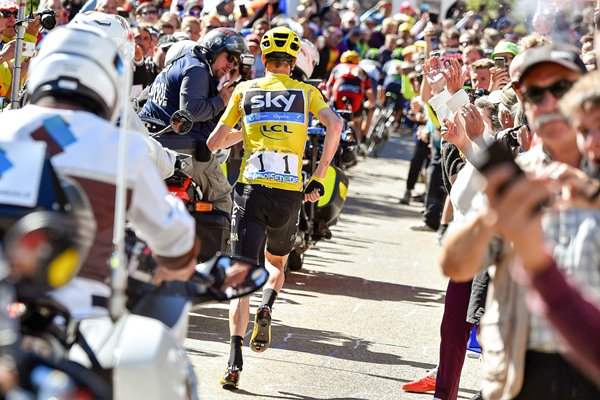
[231,182,304,260]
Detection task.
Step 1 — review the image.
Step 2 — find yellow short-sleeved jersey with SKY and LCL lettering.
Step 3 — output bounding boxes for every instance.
[221,73,328,191]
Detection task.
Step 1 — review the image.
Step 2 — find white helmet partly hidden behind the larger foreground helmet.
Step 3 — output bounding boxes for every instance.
[69,11,135,60]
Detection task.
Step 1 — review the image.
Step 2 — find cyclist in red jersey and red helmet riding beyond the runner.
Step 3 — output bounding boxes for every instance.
[325,50,375,155]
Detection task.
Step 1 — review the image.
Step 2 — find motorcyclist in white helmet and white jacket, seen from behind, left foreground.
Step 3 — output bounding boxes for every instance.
[0,26,199,319]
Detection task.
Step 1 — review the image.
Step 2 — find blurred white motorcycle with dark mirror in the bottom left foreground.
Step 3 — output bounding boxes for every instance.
[8,255,268,400]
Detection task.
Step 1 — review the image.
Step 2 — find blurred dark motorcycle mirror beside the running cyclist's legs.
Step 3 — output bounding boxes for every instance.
[192,253,269,301]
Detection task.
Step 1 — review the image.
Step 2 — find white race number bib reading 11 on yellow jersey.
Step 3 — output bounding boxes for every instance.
[244,151,300,183]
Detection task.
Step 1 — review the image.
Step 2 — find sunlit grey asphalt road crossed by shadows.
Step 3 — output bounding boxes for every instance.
[185,137,480,400]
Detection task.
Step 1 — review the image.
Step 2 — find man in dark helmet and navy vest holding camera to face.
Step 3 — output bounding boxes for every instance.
[139,28,248,215]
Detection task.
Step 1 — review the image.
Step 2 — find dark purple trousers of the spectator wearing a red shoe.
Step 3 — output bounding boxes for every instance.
[435,281,473,400]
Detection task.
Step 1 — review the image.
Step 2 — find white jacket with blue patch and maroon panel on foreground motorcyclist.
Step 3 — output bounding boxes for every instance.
[0,105,195,282]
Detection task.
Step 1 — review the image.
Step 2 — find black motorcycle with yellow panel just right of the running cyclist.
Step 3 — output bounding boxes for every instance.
[286,126,351,271]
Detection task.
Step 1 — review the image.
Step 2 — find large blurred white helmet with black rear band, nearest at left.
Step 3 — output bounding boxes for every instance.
[27,25,124,120]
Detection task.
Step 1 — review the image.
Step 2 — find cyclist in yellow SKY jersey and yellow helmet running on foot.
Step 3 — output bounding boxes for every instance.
[207,27,342,389]
